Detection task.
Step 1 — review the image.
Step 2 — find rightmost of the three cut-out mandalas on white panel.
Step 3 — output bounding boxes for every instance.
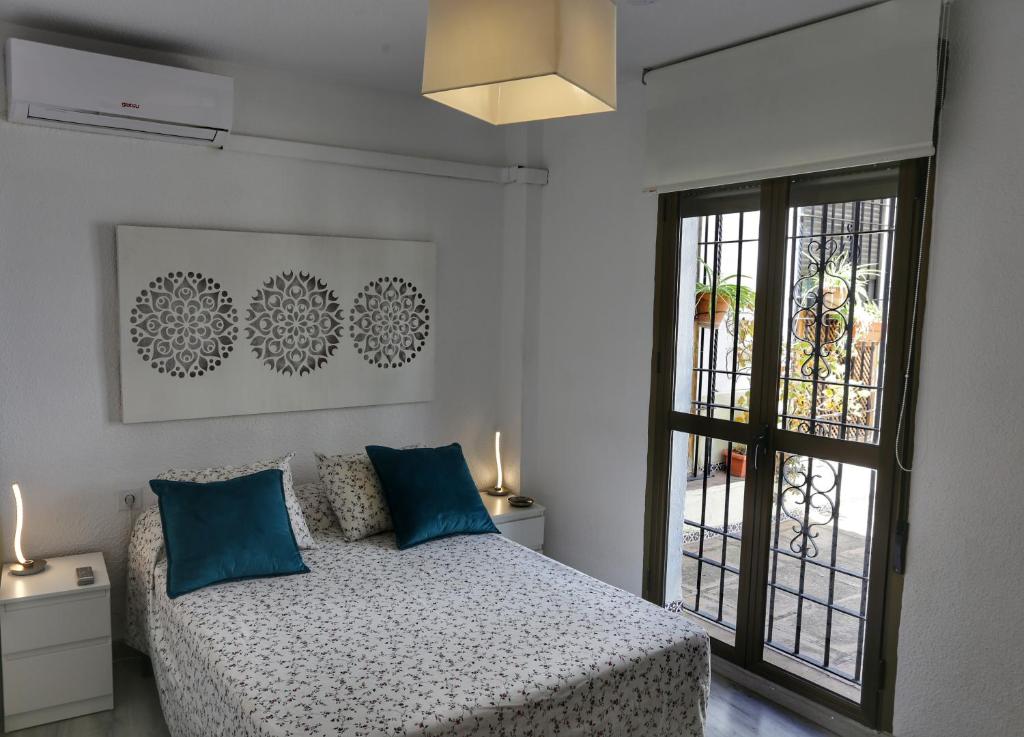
[348,276,430,369]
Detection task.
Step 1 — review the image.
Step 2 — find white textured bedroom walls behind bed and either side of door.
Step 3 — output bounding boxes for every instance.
[0,0,1024,737]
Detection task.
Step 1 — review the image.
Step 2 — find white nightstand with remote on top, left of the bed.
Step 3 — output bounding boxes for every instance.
[0,553,114,732]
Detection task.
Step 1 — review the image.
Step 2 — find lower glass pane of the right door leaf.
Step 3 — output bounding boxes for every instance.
[764,452,876,701]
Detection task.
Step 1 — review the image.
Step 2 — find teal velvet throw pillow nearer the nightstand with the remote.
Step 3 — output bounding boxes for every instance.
[150,469,309,599]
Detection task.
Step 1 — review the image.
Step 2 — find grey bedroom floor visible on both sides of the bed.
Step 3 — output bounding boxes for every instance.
[12,653,831,737]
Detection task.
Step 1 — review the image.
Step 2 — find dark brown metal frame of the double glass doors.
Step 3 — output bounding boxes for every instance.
[643,160,929,729]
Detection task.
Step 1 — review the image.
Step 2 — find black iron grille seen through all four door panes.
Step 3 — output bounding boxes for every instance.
[668,188,896,695]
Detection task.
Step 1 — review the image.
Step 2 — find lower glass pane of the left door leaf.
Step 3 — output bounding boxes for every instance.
[666,432,746,645]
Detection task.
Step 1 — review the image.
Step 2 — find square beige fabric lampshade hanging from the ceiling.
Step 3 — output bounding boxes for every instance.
[423,0,615,125]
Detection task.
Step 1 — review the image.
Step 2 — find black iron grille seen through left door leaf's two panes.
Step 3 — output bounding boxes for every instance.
[668,206,760,633]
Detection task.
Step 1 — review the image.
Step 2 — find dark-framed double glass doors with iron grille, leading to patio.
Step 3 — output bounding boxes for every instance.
[645,161,924,726]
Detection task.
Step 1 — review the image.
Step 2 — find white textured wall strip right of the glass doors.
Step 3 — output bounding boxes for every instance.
[894,0,1024,737]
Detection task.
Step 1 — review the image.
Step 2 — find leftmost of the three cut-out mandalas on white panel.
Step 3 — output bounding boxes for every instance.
[129,271,239,379]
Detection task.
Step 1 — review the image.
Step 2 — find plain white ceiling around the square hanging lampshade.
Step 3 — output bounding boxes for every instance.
[0,0,869,91]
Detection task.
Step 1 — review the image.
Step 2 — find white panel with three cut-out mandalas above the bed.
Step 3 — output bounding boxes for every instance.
[117,226,436,423]
